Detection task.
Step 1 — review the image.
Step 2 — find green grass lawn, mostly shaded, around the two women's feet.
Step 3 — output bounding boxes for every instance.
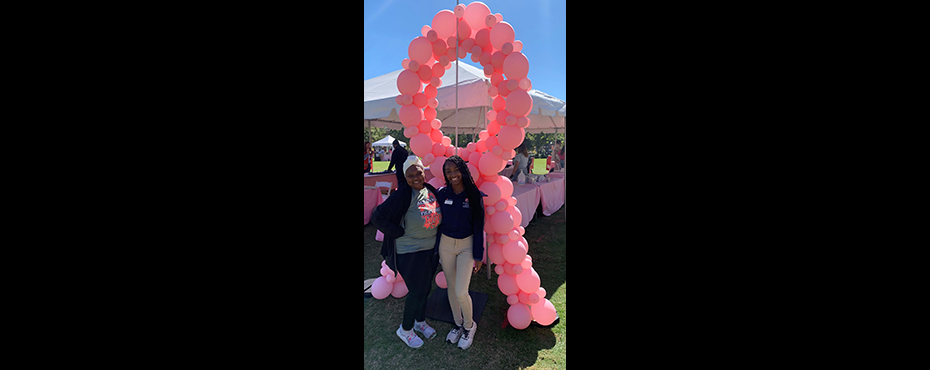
[364,205,568,369]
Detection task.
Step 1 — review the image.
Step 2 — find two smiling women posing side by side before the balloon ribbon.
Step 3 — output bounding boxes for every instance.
[371,156,484,349]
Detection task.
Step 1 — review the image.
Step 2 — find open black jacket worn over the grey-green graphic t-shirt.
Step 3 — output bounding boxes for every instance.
[371,182,442,276]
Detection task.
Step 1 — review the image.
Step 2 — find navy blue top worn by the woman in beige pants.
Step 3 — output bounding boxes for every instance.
[436,186,487,261]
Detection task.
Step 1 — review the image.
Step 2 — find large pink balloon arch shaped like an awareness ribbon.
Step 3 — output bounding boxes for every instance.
[372,1,557,329]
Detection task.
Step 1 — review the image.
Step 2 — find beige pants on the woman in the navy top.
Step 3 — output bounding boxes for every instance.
[439,235,475,329]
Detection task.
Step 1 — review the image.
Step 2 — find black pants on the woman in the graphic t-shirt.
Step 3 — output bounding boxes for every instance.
[397,249,439,330]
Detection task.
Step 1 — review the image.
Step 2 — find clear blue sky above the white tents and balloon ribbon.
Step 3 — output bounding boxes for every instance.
[364,0,568,101]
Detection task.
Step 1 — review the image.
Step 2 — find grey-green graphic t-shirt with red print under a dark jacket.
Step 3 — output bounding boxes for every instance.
[396,187,442,254]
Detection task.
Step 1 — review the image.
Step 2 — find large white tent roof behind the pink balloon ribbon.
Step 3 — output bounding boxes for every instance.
[364,62,565,136]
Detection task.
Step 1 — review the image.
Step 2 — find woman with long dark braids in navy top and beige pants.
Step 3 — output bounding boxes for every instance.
[434,155,484,349]
